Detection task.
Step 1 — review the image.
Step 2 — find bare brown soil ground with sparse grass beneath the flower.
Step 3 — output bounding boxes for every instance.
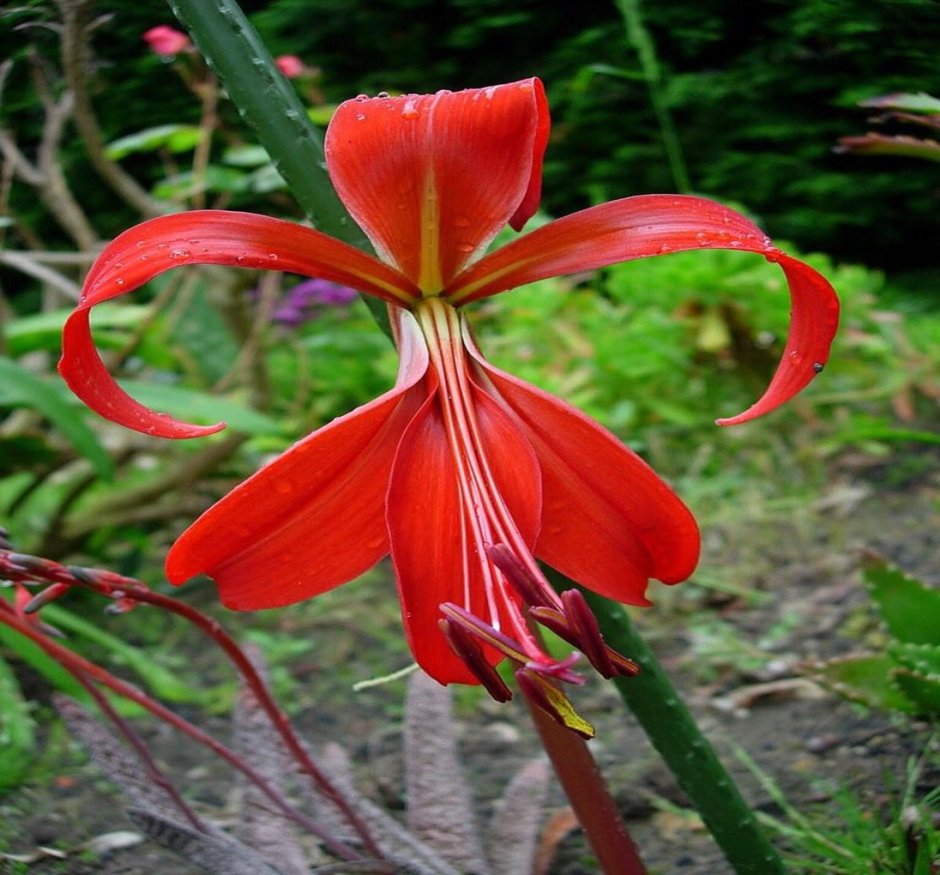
[0,468,940,875]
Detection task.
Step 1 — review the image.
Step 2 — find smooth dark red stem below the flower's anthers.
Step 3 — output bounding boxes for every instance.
[526,697,647,875]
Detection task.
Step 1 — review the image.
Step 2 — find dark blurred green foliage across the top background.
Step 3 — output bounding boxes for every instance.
[0,0,940,274]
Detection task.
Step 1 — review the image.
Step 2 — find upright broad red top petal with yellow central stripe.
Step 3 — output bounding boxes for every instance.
[326,79,549,293]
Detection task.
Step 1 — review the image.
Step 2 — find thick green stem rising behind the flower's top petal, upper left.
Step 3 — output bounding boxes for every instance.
[168,0,391,336]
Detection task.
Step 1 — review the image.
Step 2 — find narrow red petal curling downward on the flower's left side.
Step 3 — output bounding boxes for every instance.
[59,210,416,438]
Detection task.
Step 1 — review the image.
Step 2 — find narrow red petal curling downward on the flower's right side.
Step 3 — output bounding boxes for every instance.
[446,195,839,425]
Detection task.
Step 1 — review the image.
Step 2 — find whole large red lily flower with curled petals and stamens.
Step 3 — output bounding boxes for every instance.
[60,79,838,710]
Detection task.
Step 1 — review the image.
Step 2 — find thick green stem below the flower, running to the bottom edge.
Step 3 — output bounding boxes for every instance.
[584,591,786,875]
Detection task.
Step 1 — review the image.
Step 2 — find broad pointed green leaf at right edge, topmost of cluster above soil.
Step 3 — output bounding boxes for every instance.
[863,558,940,644]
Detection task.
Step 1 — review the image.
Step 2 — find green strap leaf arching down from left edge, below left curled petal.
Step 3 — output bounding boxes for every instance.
[0,357,112,479]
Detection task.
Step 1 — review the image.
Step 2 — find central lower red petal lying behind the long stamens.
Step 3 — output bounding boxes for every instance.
[387,362,541,684]
